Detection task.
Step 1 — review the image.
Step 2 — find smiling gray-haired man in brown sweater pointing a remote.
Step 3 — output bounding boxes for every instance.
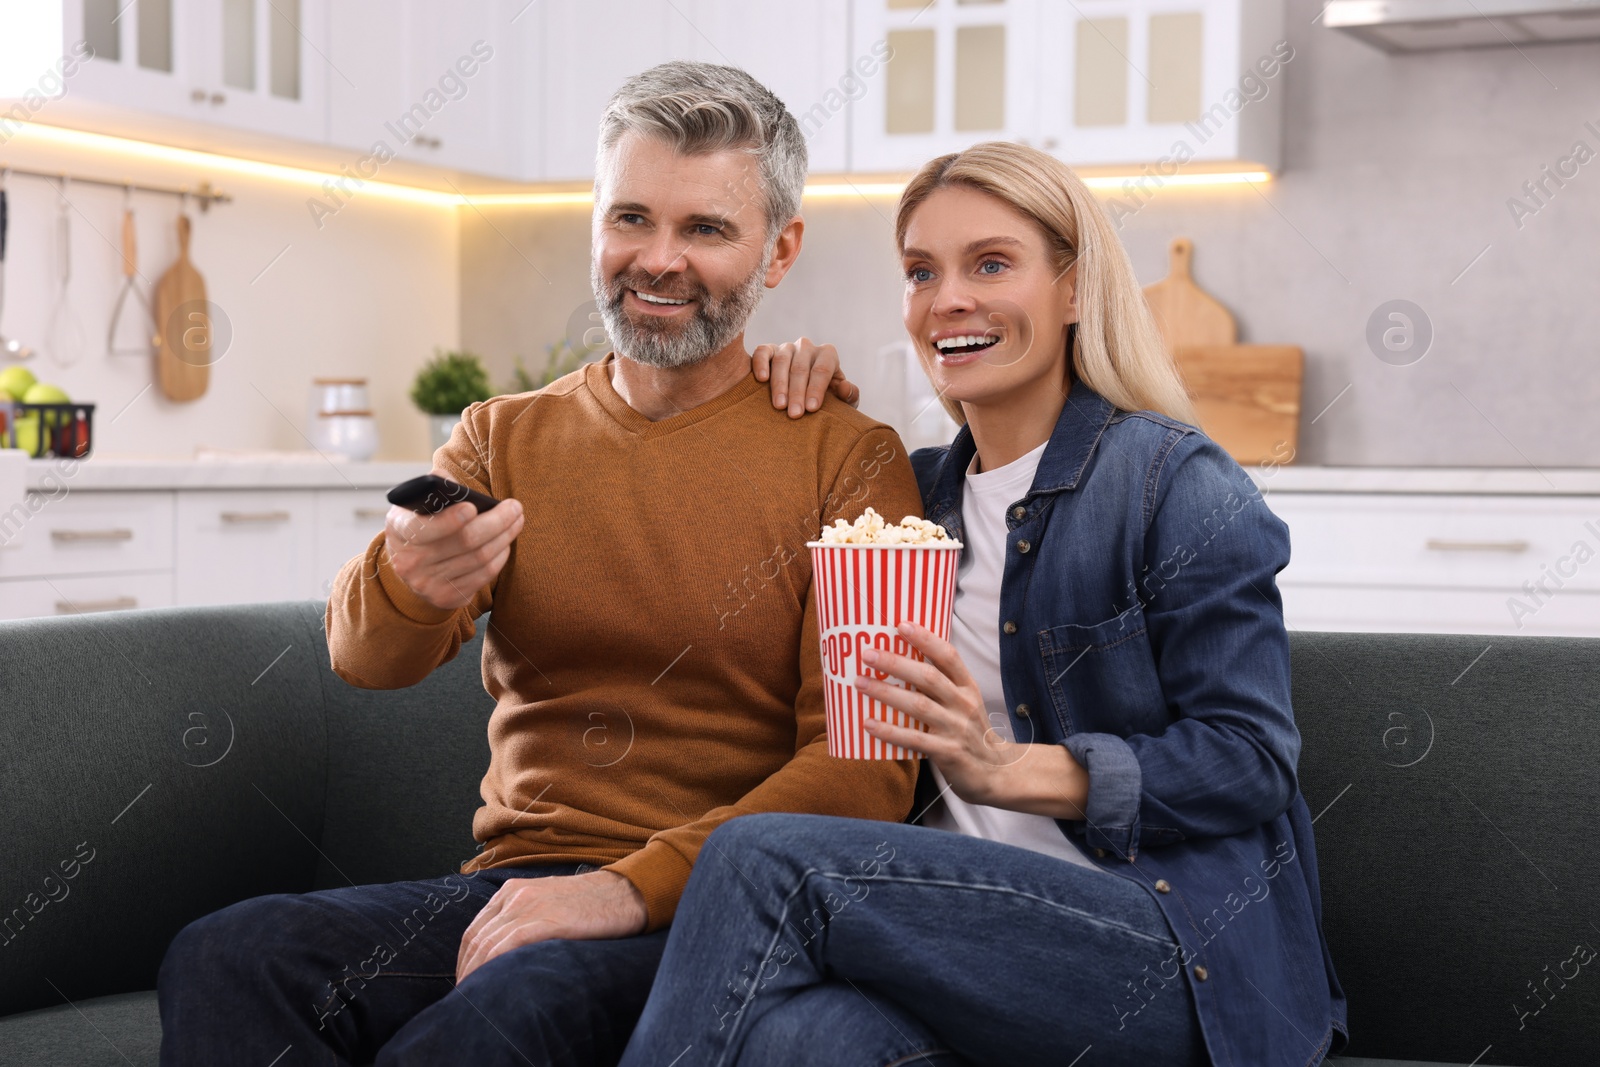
[160,62,922,1067]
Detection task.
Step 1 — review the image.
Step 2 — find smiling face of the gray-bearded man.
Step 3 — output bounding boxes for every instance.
[590,133,782,366]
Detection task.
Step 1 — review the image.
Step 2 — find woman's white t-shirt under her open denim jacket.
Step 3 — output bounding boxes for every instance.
[923,442,1099,870]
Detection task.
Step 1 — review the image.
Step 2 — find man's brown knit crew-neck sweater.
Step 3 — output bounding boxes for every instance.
[328,357,922,929]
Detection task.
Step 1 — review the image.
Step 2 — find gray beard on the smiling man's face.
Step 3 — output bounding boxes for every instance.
[589,246,773,368]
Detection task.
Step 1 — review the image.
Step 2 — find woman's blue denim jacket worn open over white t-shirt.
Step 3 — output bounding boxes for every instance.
[910,381,1346,1067]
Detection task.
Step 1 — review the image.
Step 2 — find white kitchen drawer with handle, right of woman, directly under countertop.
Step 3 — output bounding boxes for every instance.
[1264,491,1600,593]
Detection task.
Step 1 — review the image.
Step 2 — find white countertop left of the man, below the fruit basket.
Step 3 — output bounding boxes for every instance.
[26,456,430,490]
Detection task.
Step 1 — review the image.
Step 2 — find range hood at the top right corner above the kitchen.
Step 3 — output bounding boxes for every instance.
[1322,0,1600,51]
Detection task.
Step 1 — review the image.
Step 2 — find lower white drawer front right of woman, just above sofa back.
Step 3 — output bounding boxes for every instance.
[1278,582,1600,637]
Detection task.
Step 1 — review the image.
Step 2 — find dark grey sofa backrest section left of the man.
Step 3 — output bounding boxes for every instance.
[0,601,491,1014]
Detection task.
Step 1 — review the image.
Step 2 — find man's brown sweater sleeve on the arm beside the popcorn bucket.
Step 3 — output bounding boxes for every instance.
[608,427,922,929]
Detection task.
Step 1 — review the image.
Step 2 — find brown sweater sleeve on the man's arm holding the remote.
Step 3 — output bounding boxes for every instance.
[325,405,510,689]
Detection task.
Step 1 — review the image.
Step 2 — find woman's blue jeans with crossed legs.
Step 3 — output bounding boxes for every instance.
[622,814,1210,1067]
